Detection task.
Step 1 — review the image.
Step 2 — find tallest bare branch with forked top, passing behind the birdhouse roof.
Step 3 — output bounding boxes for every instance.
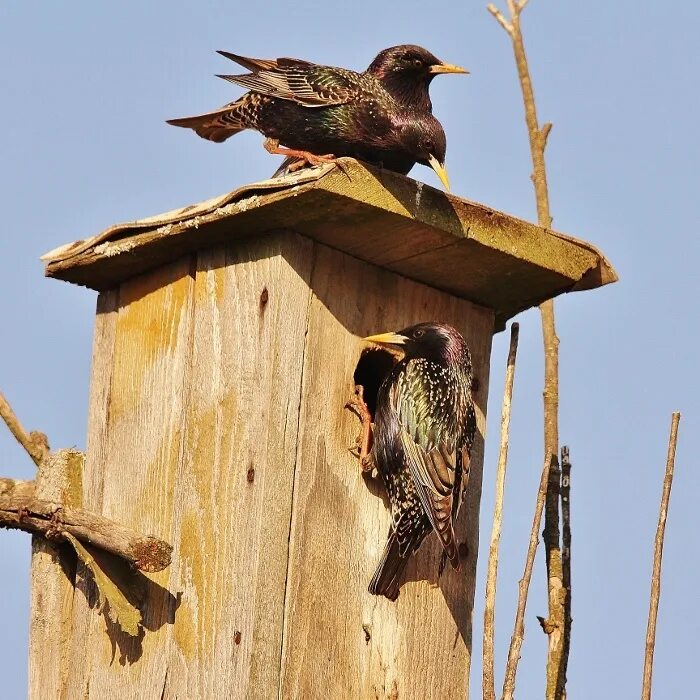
[488,0,567,700]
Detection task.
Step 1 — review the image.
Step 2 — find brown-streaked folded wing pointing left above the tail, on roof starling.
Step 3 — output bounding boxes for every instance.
[219,58,358,107]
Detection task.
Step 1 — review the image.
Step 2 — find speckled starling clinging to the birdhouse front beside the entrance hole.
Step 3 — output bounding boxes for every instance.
[365,323,476,600]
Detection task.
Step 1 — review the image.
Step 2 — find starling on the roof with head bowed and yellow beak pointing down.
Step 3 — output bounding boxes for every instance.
[168,48,449,189]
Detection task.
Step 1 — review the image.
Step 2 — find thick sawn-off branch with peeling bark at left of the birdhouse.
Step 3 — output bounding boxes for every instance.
[0,479,172,572]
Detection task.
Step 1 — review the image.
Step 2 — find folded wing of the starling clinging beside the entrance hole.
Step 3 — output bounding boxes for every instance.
[391,359,462,566]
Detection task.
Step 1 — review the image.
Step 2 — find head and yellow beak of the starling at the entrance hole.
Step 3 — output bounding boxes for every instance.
[364,322,469,362]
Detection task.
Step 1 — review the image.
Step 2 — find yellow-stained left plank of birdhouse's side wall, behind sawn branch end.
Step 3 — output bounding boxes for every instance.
[62,258,194,698]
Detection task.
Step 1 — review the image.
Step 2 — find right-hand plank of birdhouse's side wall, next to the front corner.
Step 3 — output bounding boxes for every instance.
[165,234,312,699]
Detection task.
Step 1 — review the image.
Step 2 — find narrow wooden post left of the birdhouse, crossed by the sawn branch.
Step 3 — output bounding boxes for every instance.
[29,449,83,700]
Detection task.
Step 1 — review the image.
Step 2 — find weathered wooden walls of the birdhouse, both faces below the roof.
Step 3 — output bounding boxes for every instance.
[32,233,493,700]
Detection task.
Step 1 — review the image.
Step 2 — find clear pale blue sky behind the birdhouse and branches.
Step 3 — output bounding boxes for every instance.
[0,0,700,698]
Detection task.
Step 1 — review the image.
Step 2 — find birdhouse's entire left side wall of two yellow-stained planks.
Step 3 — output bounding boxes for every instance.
[56,234,313,698]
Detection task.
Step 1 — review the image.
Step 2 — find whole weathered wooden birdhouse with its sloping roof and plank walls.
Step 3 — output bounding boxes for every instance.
[37,160,616,700]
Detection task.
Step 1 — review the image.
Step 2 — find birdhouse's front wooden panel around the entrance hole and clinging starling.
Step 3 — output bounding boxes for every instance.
[281,244,493,700]
